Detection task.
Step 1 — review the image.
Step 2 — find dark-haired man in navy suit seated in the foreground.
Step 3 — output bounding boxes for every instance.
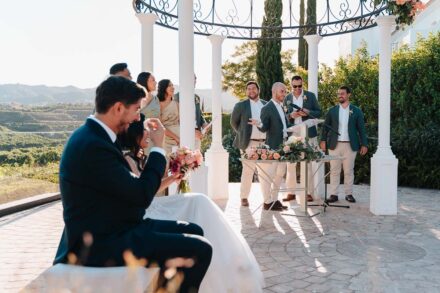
[54,76,212,292]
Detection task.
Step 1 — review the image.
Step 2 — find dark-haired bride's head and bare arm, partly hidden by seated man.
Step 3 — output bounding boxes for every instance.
[118,113,180,193]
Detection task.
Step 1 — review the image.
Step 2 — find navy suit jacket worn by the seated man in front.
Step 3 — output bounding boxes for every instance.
[54,119,166,266]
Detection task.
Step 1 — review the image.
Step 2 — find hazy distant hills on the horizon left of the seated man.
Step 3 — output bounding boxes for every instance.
[0,84,95,105]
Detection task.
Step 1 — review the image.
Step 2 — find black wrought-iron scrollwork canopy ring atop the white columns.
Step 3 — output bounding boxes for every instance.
[133,0,387,40]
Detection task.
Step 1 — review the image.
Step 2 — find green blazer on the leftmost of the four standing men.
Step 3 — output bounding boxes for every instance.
[230,99,267,150]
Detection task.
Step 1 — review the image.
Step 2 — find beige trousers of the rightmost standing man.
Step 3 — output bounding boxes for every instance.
[329,142,357,195]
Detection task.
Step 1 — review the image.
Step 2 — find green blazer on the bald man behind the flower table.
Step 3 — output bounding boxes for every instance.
[259,100,291,149]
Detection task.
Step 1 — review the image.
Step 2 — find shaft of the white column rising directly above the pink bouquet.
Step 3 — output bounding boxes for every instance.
[178,0,196,149]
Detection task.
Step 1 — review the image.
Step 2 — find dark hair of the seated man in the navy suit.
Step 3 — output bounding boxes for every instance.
[95,76,145,114]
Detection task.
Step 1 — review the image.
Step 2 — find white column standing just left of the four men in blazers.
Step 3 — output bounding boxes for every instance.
[206,35,229,199]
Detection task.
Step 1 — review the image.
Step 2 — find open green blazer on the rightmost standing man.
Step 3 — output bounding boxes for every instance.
[321,104,368,152]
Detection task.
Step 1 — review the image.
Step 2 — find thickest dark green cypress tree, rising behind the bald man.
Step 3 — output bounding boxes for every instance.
[256,0,284,100]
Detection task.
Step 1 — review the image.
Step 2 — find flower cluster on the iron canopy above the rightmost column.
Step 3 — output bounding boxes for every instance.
[374,0,425,25]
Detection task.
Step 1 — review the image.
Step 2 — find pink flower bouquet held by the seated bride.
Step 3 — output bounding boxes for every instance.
[169,147,203,193]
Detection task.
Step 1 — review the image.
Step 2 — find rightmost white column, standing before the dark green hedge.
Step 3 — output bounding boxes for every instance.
[370,15,398,215]
